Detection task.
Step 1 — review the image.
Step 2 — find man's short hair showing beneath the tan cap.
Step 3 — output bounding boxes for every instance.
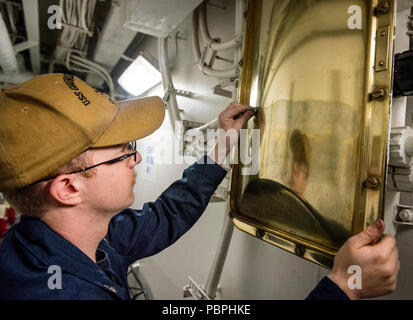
[3,151,96,218]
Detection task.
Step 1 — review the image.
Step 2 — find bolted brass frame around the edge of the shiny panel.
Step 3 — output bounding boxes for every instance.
[228,0,396,268]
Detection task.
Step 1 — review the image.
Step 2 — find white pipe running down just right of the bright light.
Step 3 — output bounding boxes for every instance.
[158,38,181,133]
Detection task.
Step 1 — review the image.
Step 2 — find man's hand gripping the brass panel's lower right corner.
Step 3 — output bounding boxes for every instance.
[328,219,400,300]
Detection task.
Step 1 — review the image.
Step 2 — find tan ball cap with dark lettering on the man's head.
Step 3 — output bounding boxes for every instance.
[0,74,165,191]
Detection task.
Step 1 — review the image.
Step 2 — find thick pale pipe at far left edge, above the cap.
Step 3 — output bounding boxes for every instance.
[0,14,19,75]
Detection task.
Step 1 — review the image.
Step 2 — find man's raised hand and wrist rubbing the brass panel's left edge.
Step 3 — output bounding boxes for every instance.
[209,102,255,165]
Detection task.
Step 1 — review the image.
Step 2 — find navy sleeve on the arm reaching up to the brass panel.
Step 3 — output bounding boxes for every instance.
[106,156,227,264]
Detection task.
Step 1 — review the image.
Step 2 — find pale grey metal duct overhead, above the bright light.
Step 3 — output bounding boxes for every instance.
[124,0,202,38]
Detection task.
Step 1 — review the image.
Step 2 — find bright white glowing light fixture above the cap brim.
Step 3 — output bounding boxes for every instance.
[118,55,162,96]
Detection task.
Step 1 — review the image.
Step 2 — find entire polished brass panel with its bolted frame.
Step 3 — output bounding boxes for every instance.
[229,0,395,268]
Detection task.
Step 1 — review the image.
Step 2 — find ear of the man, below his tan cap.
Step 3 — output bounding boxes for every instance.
[49,174,82,206]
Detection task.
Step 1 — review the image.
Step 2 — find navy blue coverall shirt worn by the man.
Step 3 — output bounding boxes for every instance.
[0,156,346,300]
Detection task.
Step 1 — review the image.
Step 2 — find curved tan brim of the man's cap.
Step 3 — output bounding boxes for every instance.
[91,97,165,148]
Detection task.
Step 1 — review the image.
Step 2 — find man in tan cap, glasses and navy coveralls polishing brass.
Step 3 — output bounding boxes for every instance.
[0,74,398,299]
